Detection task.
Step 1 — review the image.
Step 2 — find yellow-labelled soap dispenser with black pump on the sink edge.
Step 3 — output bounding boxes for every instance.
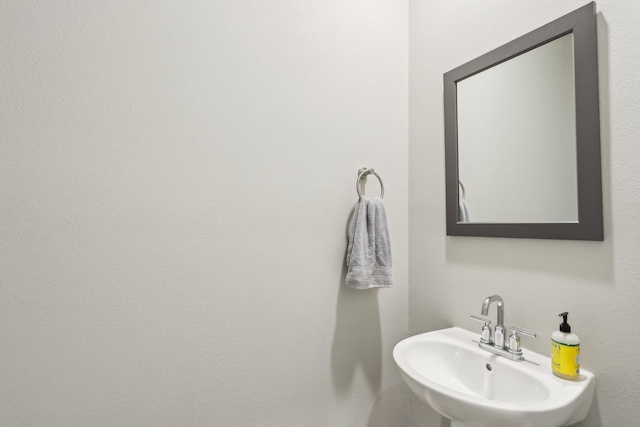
[551,312,580,380]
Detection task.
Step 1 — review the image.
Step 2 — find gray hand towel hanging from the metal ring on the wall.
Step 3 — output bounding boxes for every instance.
[346,196,393,289]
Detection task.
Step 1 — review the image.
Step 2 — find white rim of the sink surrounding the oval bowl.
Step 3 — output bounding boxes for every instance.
[393,326,595,414]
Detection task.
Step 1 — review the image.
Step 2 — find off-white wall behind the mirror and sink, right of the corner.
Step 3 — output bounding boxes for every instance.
[409,0,640,427]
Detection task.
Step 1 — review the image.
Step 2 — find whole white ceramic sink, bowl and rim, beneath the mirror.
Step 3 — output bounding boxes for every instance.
[393,327,595,427]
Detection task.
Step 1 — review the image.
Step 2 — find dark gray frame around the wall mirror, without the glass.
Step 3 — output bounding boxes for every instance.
[444,2,604,241]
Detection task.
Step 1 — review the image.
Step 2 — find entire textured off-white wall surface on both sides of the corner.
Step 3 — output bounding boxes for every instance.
[6,0,640,427]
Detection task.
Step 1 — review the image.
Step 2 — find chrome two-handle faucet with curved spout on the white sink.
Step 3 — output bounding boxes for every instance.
[471,295,536,361]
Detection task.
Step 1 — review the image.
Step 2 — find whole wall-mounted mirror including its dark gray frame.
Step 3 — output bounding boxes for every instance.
[444,3,603,240]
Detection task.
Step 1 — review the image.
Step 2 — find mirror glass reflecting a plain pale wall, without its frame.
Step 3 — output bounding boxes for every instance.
[457,34,578,223]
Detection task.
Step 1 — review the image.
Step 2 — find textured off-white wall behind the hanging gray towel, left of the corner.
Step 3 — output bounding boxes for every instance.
[0,0,408,427]
